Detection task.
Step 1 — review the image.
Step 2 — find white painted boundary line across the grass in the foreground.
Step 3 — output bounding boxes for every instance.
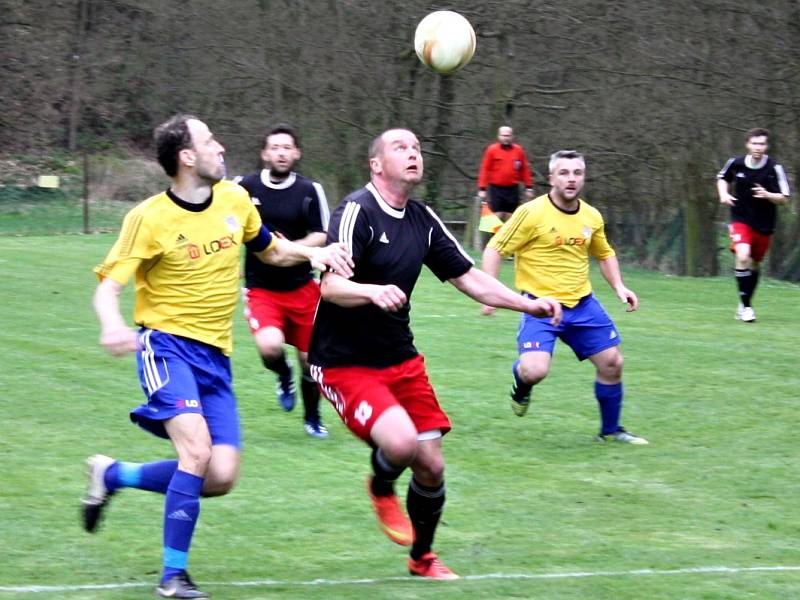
[0,565,800,594]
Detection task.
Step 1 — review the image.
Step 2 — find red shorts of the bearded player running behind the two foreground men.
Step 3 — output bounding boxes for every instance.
[244,279,319,352]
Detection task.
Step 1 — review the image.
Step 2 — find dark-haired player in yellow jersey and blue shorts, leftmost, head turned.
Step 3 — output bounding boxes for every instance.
[82,115,352,598]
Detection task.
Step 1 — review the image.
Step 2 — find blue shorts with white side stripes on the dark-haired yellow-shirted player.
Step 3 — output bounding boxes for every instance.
[130,328,242,448]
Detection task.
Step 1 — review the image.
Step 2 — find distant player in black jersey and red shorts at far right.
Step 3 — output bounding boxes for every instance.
[717,128,789,323]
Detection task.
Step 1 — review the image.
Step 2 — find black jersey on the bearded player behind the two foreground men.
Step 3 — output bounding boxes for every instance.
[234,169,330,291]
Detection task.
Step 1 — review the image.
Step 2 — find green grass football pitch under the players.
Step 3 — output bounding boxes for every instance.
[0,235,800,600]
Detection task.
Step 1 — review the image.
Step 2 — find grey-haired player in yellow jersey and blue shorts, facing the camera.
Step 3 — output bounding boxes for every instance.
[483,150,648,444]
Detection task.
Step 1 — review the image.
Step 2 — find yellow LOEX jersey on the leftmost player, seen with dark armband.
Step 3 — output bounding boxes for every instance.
[94,181,277,354]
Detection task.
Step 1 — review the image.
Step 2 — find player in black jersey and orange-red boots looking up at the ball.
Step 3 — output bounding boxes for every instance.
[309,129,561,579]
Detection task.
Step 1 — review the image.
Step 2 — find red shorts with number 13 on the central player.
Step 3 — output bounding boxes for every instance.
[311,355,451,443]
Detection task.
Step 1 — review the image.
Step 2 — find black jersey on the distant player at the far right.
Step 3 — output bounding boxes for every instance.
[717,156,789,235]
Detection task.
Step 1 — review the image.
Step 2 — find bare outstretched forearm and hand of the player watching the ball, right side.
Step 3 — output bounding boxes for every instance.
[448,268,561,325]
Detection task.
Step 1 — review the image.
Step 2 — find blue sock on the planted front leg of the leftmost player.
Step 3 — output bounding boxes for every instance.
[161,469,203,583]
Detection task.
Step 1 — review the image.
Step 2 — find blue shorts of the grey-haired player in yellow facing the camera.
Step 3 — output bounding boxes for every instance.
[517,294,620,360]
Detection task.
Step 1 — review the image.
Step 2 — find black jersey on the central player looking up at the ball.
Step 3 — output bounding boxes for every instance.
[309,184,473,368]
